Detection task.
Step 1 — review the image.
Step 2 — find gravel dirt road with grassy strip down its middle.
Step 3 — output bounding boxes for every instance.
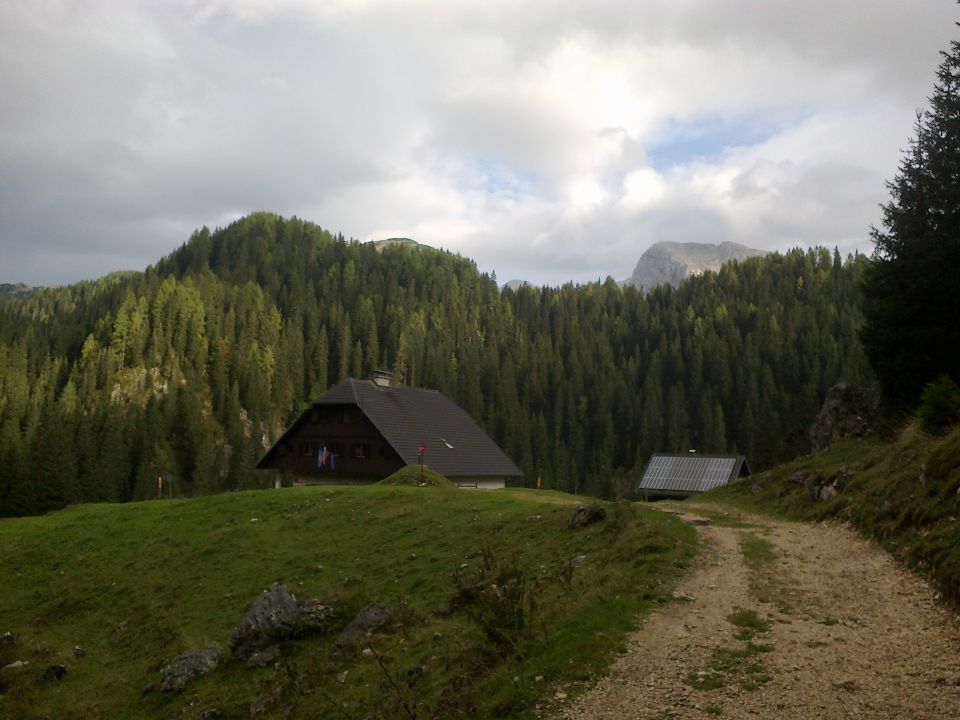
[557,504,960,720]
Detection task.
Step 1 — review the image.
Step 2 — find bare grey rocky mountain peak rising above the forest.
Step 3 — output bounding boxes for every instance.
[622,242,769,290]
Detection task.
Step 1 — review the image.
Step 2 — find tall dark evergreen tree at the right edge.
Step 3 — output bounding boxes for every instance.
[862,36,960,411]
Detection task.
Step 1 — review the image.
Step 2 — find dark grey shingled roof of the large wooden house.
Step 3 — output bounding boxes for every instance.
[258,378,523,477]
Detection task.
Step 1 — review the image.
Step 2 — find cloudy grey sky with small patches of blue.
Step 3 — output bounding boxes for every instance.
[0,0,960,285]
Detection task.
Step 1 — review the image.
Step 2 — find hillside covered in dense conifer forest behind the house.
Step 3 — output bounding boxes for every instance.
[0,213,866,515]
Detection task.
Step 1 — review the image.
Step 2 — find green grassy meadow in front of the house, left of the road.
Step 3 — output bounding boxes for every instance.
[0,486,696,718]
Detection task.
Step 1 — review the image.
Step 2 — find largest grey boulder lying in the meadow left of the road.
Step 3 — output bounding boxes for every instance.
[230,583,336,660]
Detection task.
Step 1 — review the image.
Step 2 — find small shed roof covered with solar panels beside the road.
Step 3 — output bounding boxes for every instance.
[637,453,750,495]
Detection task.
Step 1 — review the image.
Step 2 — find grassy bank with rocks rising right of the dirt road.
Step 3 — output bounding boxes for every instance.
[704,426,960,605]
